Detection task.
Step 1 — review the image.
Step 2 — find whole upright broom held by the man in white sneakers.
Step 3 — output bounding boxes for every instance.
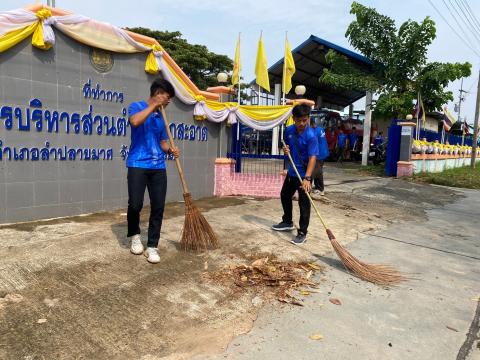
[161,106,219,251]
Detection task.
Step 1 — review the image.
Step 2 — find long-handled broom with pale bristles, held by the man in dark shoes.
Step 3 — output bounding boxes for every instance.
[282,140,406,286]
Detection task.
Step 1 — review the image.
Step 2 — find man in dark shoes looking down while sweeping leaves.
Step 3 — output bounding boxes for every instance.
[272,104,318,244]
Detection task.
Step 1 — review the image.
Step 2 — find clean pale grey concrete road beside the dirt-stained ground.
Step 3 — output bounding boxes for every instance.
[208,191,480,360]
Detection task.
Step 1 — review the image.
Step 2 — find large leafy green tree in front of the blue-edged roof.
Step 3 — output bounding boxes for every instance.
[320,2,472,117]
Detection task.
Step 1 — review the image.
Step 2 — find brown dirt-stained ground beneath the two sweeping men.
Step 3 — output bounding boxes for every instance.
[0,174,457,360]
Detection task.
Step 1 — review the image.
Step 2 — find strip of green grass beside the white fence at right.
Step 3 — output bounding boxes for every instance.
[413,164,480,189]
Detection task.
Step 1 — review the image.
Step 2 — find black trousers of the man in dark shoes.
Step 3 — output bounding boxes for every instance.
[280,175,311,234]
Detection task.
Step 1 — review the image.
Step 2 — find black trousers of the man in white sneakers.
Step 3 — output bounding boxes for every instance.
[127,167,167,247]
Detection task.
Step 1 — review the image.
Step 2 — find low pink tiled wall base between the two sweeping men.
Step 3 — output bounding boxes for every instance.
[213,158,284,198]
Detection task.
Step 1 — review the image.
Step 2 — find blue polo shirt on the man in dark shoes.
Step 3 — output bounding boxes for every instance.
[283,125,318,178]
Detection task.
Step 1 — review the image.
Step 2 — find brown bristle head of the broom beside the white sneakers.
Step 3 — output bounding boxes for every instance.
[180,193,219,251]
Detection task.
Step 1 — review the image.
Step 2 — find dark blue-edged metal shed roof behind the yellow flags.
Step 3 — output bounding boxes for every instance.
[251,35,373,108]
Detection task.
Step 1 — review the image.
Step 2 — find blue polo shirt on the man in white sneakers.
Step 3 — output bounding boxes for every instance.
[127,100,168,170]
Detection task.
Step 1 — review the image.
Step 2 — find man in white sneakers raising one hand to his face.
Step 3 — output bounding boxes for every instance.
[127,79,179,263]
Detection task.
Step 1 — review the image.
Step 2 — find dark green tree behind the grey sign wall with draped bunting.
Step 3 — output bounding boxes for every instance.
[128,27,233,89]
